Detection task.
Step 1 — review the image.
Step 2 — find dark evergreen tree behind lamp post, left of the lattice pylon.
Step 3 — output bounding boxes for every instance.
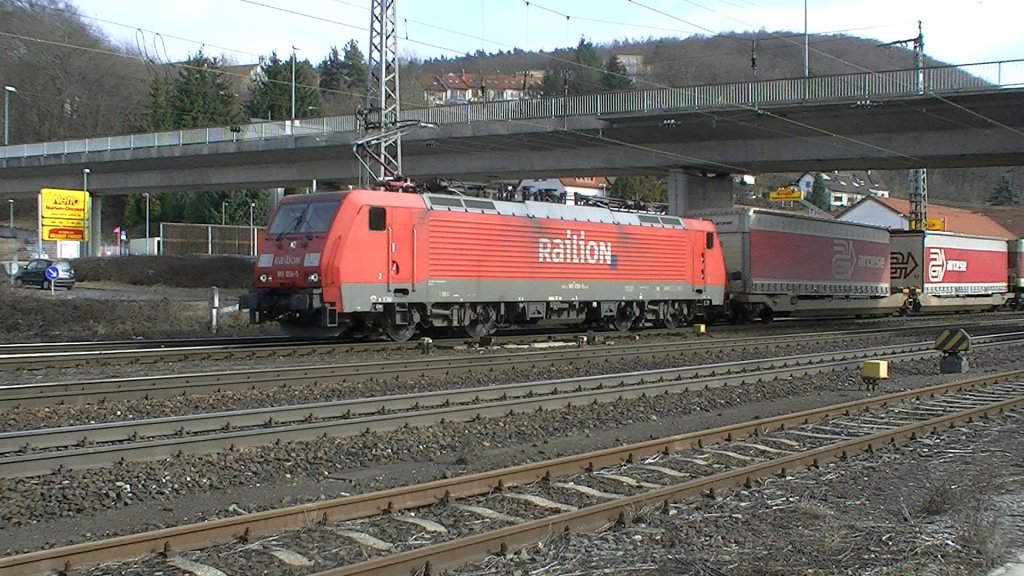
[245,51,323,120]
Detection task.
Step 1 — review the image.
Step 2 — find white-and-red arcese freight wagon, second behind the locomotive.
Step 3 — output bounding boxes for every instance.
[891,231,1011,312]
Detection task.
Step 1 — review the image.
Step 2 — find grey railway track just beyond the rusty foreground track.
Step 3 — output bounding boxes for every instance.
[0,332,1024,478]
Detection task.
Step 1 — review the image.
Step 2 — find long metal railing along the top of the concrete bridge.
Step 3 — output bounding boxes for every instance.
[0,59,1024,159]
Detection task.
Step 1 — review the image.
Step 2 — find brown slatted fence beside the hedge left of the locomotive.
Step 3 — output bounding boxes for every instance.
[160,222,264,256]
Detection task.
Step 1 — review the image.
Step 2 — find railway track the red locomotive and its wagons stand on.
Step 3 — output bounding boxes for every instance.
[0,315,1020,372]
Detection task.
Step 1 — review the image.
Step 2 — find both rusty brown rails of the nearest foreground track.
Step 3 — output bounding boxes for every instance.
[0,370,1024,576]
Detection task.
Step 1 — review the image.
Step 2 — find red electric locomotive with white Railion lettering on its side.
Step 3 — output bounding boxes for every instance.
[242,190,725,340]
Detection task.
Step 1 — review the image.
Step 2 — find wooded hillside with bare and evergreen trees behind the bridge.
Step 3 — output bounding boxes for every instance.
[0,0,1024,219]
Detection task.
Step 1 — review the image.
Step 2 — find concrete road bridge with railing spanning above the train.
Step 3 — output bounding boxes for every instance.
[0,59,1024,197]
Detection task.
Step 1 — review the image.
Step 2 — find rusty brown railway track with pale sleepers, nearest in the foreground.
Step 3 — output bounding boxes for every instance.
[0,371,1024,576]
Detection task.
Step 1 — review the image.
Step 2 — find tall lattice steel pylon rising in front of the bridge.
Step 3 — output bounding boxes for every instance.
[353,0,401,188]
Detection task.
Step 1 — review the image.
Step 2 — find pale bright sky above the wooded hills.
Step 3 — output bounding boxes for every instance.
[70,0,1024,72]
